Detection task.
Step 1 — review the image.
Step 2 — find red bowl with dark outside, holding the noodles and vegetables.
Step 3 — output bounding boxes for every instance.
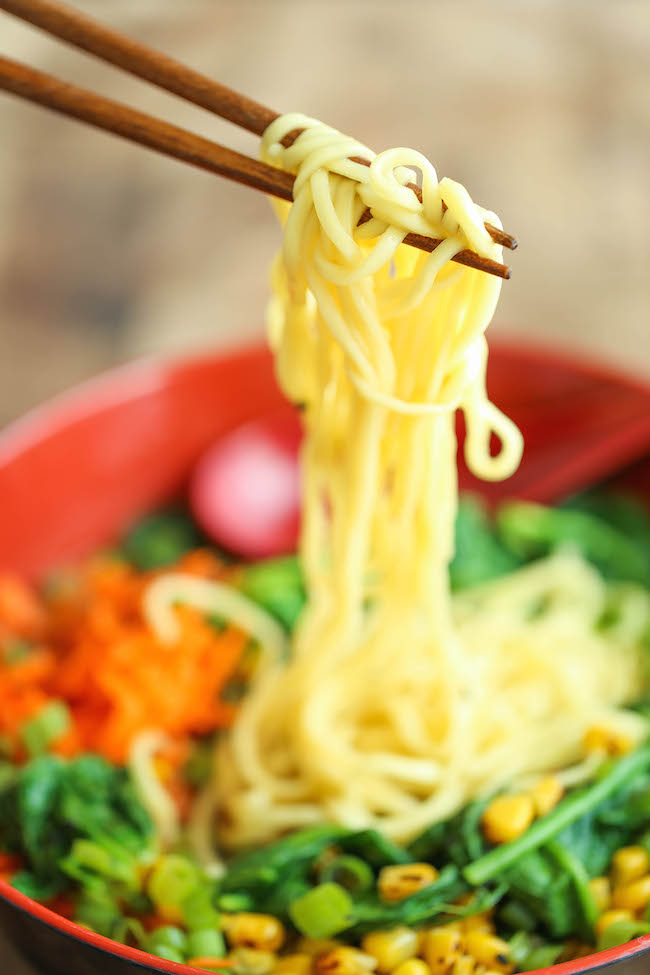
[0,345,650,975]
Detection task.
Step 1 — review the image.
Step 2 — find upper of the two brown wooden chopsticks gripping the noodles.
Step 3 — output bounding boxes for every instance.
[0,0,517,250]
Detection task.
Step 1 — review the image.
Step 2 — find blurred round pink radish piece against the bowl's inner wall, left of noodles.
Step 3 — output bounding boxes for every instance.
[190,410,301,558]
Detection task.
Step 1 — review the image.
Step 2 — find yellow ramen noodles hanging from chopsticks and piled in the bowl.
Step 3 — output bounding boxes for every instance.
[217,115,647,845]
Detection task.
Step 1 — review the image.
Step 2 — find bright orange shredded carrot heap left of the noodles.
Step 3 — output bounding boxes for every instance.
[0,550,247,768]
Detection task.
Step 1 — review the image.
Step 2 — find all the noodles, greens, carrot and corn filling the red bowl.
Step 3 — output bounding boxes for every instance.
[0,114,650,975]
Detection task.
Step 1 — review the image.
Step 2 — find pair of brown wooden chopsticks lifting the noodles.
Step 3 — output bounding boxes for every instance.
[0,0,517,278]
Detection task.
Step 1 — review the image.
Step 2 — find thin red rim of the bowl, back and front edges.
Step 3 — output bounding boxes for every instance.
[0,338,650,975]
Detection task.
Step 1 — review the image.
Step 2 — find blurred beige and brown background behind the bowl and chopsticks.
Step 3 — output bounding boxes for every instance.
[0,0,650,423]
